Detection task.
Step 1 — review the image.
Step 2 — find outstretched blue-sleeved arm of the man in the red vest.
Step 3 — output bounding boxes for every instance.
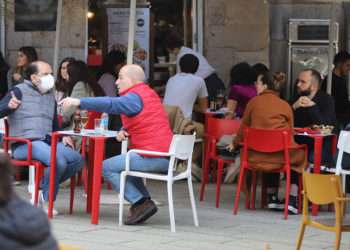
[80,93,143,116]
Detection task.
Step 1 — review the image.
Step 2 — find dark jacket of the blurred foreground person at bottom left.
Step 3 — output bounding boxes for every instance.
[0,196,58,250]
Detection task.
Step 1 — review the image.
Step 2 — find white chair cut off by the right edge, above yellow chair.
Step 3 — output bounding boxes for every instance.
[335,130,350,192]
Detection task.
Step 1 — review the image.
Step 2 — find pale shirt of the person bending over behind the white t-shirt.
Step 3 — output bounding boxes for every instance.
[176,47,215,79]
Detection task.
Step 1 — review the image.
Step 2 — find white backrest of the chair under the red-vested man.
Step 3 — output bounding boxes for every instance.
[169,133,196,160]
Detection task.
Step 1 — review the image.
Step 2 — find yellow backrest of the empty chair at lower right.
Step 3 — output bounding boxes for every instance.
[303,172,343,205]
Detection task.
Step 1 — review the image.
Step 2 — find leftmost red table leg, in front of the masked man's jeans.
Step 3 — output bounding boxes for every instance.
[48,133,58,219]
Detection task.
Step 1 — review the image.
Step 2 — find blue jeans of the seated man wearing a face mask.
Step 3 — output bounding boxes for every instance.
[13,141,84,201]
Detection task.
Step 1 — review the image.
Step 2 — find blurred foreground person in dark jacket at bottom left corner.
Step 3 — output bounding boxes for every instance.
[0,153,58,250]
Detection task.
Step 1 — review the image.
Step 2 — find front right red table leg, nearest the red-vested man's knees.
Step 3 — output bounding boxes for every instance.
[91,137,105,225]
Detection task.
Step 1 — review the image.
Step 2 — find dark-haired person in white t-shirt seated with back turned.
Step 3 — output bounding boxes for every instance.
[163,54,208,119]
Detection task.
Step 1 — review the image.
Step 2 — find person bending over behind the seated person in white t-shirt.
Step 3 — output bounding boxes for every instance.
[167,37,225,101]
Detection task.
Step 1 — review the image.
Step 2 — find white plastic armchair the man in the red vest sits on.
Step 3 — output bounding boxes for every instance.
[119,134,198,232]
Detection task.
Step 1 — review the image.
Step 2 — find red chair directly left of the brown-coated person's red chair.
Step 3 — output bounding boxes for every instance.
[200,117,241,208]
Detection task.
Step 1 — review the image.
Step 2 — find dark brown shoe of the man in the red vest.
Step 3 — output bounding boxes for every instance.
[124,199,158,225]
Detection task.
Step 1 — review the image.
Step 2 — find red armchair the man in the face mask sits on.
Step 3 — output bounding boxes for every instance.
[3,119,75,214]
